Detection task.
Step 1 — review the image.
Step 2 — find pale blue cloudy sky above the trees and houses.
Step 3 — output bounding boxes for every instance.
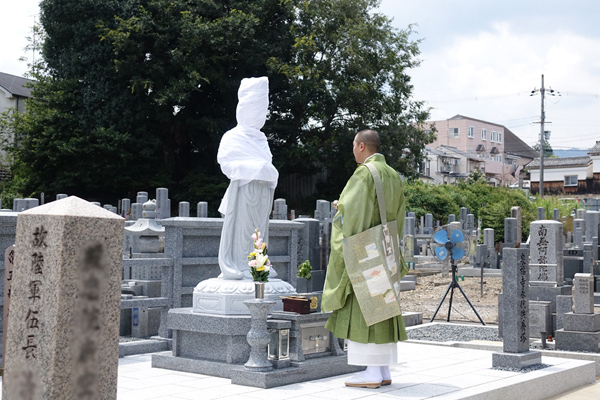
[0,0,600,149]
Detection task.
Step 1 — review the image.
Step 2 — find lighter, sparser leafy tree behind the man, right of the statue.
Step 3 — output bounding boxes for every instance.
[269,0,435,197]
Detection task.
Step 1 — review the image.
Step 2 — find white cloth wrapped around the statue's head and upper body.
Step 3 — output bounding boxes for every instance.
[217,77,279,213]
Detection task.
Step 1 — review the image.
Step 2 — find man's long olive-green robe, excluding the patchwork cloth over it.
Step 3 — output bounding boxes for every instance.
[321,154,408,344]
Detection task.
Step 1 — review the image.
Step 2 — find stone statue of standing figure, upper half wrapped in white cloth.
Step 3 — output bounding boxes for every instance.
[217,77,279,280]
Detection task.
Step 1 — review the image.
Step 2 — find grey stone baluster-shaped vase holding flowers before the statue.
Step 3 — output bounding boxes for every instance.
[244,298,275,372]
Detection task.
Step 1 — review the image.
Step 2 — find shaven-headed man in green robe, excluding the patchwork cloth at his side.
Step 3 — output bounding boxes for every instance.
[321,130,408,388]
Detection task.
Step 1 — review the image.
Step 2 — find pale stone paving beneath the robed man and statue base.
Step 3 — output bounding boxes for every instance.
[0,342,600,400]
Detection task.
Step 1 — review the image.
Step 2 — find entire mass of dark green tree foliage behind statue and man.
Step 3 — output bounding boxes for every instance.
[8,0,433,214]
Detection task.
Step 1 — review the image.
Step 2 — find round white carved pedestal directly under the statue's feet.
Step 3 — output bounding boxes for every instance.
[192,278,296,315]
